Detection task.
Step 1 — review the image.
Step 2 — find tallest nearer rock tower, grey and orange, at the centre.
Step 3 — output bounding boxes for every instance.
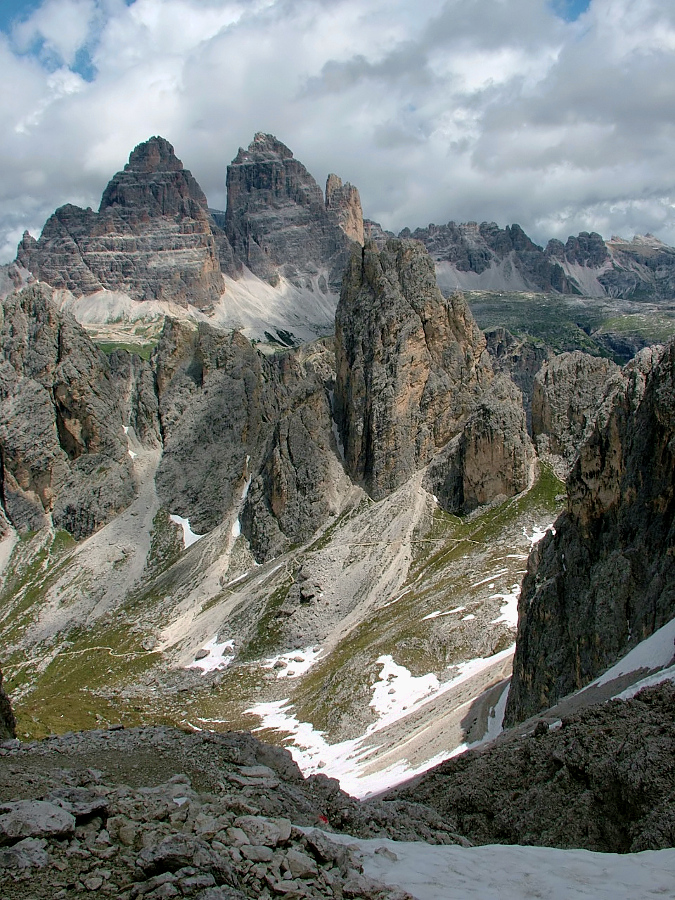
[335,240,492,499]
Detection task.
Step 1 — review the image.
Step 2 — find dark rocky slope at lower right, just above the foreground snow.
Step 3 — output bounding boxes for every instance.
[394,682,675,853]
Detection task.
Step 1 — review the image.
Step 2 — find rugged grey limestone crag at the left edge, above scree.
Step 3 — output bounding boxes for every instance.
[0,285,134,538]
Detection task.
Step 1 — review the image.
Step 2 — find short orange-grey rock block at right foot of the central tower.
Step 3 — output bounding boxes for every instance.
[425,375,535,513]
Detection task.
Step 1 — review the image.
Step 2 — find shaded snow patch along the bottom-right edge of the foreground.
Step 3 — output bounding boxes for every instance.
[326,834,675,900]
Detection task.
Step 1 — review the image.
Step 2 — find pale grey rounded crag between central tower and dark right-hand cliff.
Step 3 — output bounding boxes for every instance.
[532,350,621,465]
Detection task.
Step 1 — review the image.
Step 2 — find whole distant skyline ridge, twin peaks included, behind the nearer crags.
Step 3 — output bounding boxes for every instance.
[5,132,675,332]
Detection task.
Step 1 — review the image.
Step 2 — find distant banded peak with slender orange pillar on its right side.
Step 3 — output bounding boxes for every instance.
[226,133,363,293]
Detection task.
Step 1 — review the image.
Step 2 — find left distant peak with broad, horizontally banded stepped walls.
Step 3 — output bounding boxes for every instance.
[17,137,226,308]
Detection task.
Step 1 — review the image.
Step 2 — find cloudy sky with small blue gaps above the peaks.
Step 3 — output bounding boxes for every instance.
[0,0,675,262]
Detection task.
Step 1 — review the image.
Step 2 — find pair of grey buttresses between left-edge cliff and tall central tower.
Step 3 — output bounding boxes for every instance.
[155,319,347,559]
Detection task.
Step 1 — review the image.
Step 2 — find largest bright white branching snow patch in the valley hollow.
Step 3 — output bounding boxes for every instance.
[246,647,514,797]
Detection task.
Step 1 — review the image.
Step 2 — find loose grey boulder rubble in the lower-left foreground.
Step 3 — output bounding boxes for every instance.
[0,728,465,900]
